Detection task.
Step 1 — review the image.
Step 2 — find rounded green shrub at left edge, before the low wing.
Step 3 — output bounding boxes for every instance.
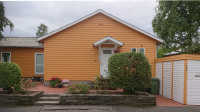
[0,62,21,93]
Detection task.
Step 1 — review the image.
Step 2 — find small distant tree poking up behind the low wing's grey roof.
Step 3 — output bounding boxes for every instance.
[36,23,48,37]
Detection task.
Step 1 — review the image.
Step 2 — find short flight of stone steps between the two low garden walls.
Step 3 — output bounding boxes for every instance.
[35,93,60,105]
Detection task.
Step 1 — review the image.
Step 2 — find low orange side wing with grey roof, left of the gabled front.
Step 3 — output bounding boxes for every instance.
[0,37,44,77]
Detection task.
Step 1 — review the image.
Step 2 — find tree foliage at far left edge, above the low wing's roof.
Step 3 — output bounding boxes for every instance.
[0,1,14,39]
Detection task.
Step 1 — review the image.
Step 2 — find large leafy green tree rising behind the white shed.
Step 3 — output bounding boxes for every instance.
[152,0,200,53]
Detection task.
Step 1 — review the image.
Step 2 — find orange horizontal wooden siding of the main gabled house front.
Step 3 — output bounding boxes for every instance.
[43,14,156,81]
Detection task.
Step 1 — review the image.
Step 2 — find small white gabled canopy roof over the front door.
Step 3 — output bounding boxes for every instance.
[94,36,124,47]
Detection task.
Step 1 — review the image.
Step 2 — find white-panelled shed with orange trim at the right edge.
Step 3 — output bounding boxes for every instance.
[156,54,200,105]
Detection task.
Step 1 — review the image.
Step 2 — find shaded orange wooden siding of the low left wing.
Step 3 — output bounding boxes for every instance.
[0,47,43,77]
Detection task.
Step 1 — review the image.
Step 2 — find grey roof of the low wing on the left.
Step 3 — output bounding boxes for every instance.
[0,37,43,48]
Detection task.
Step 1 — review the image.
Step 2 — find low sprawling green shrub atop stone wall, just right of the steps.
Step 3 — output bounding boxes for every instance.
[67,83,90,94]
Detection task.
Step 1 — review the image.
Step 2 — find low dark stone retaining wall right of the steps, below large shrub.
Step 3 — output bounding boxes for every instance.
[60,92,156,106]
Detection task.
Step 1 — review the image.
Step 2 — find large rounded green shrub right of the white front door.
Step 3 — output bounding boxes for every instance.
[108,53,151,94]
